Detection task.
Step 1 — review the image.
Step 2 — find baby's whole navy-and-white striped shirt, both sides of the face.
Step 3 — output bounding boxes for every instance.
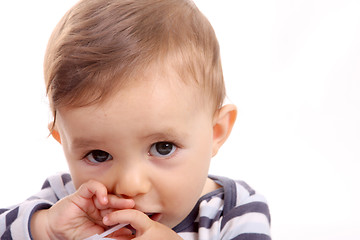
[0,174,271,240]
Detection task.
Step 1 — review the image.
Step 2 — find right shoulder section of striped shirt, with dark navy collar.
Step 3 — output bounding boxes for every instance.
[174,176,271,240]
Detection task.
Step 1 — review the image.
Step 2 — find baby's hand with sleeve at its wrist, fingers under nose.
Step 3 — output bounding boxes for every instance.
[31,180,134,239]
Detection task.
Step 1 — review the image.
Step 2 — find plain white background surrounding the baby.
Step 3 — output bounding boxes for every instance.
[0,0,360,240]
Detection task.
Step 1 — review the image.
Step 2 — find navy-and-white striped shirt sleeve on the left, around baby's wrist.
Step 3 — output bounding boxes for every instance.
[0,174,75,240]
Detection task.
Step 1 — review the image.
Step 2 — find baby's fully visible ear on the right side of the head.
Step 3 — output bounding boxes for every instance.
[212,104,237,156]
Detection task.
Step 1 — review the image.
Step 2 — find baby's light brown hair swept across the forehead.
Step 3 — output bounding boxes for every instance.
[44,0,225,130]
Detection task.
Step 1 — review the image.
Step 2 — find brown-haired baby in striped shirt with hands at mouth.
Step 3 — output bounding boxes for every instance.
[0,0,271,240]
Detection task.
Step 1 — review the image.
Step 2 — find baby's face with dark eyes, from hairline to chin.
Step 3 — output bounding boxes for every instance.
[56,74,218,227]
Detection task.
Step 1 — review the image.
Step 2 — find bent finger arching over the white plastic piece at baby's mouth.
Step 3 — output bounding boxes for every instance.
[103,209,153,234]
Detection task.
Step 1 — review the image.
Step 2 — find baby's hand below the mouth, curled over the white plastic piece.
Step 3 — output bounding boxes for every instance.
[104,209,182,240]
